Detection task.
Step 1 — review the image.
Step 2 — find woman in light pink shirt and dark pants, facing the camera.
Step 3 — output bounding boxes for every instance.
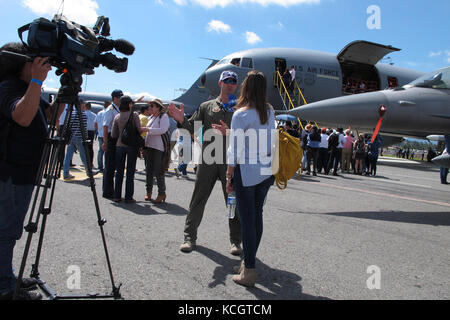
[144,99,169,204]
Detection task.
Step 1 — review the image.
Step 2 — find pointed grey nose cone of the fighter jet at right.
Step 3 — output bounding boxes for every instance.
[289,92,387,127]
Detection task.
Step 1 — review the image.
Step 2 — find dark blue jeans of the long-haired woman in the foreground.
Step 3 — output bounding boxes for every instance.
[234,166,275,269]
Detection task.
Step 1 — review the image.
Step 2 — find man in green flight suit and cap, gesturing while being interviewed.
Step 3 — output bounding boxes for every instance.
[169,71,242,256]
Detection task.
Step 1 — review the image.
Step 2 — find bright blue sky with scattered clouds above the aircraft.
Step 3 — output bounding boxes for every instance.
[0,0,450,100]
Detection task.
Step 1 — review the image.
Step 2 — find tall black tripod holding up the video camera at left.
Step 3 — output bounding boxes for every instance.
[13,70,122,300]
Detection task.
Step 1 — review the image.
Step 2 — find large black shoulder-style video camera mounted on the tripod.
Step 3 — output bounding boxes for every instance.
[18,15,135,75]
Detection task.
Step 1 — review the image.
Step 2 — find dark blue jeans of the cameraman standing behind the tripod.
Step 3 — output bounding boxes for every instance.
[0,179,34,293]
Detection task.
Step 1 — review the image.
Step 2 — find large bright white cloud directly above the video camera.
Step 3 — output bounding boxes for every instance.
[22,0,99,26]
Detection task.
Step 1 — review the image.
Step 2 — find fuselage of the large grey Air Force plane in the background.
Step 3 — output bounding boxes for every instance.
[203,48,423,109]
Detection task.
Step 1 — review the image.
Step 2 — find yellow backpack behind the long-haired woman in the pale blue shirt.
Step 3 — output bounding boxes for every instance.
[272,128,303,190]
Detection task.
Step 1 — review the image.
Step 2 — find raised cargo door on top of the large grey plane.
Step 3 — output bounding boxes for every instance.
[337,40,401,65]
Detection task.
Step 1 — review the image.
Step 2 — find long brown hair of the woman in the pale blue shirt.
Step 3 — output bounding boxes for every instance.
[238,70,269,124]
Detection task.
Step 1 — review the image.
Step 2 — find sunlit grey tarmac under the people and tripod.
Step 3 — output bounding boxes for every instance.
[14,150,450,301]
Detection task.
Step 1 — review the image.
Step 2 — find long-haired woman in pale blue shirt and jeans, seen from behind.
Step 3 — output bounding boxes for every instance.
[227,70,275,286]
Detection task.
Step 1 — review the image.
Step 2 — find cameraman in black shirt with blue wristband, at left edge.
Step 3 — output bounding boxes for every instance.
[0,43,62,300]
